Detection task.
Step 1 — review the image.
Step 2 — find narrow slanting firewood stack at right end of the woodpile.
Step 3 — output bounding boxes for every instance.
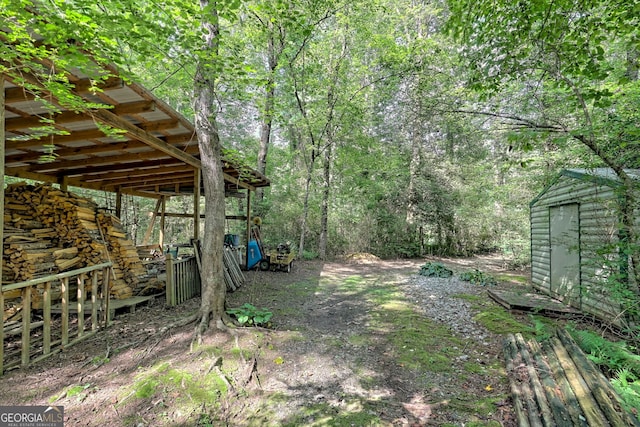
[96,211,147,298]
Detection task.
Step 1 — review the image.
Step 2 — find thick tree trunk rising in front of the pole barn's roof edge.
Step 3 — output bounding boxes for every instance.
[194,0,227,341]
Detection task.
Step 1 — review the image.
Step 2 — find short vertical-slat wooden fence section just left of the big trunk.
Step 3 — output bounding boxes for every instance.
[166,253,200,306]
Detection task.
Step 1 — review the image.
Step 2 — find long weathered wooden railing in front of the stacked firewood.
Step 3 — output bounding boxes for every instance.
[0,262,112,375]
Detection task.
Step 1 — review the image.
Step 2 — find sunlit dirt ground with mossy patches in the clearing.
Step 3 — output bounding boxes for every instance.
[0,257,524,426]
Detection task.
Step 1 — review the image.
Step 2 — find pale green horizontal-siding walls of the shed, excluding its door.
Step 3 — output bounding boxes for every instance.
[530,174,622,323]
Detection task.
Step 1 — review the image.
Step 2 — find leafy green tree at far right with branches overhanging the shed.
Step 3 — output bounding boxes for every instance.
[449,0,640,292]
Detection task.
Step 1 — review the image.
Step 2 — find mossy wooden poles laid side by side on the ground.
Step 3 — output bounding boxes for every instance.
[504,330,640,427]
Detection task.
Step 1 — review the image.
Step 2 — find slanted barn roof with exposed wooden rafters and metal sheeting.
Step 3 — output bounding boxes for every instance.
[4,52,270,197]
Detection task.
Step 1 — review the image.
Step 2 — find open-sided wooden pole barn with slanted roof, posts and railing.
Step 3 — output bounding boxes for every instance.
[0,52,269,375]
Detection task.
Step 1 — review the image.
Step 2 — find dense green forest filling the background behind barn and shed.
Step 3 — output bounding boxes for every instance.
[2,0,640,267]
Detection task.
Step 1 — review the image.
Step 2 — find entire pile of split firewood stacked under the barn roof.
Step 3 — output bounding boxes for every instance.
[2,183,158,320]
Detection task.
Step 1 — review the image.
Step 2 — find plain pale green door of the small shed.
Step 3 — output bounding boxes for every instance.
[549,203,580,308]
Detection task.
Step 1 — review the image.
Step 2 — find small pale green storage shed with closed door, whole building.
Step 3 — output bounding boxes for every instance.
[530,168,640,326]
